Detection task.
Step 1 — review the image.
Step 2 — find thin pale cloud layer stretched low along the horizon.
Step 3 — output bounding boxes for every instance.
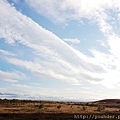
[0,83,113,100]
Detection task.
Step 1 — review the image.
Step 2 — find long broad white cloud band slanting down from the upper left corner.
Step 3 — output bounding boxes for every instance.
[0,1,104,84]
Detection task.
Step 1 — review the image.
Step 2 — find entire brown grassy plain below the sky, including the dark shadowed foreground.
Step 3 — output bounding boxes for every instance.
[0,99,120,120]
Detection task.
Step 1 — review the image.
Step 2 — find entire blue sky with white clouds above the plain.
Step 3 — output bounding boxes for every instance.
[0,0,120,101]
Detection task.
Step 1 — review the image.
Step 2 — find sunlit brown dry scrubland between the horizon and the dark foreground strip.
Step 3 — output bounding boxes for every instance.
[0,99,120,120]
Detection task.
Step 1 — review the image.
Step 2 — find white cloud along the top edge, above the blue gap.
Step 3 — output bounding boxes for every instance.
[26,0,119,22]
